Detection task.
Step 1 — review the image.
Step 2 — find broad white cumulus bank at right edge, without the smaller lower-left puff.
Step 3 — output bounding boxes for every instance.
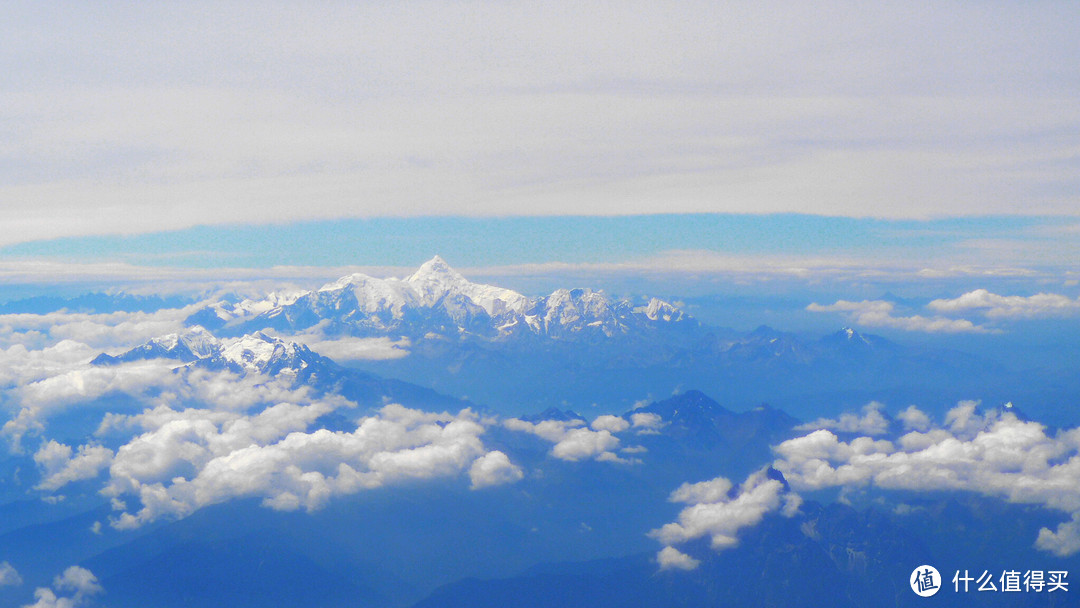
[773,402,1080,554]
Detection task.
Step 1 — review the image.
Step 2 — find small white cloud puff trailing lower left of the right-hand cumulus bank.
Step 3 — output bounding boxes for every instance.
[649,469,801,569]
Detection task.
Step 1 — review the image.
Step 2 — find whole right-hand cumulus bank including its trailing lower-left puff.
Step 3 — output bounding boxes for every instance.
[650,401,1080,568]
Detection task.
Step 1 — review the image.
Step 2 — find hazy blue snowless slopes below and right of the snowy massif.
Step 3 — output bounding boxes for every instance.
[350,324,1010,419]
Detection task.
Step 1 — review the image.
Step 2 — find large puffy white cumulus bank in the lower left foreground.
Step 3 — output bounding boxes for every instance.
[86,402,523,529]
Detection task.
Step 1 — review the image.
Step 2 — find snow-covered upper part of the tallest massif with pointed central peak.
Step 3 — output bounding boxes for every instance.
[188,256,697,340]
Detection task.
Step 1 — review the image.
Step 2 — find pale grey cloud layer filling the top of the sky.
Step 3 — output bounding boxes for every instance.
[0,2,1080,249]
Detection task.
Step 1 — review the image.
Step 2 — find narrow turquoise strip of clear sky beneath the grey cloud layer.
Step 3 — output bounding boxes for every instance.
[0,214,1067,268]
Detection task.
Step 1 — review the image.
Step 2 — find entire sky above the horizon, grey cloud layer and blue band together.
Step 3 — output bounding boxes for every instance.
[0,1,1080,321]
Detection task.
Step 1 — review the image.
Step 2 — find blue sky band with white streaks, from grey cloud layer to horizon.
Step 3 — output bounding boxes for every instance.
[0,214,1080,302]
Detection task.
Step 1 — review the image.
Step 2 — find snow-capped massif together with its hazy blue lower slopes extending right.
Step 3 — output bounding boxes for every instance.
[170,256,1028,418]
